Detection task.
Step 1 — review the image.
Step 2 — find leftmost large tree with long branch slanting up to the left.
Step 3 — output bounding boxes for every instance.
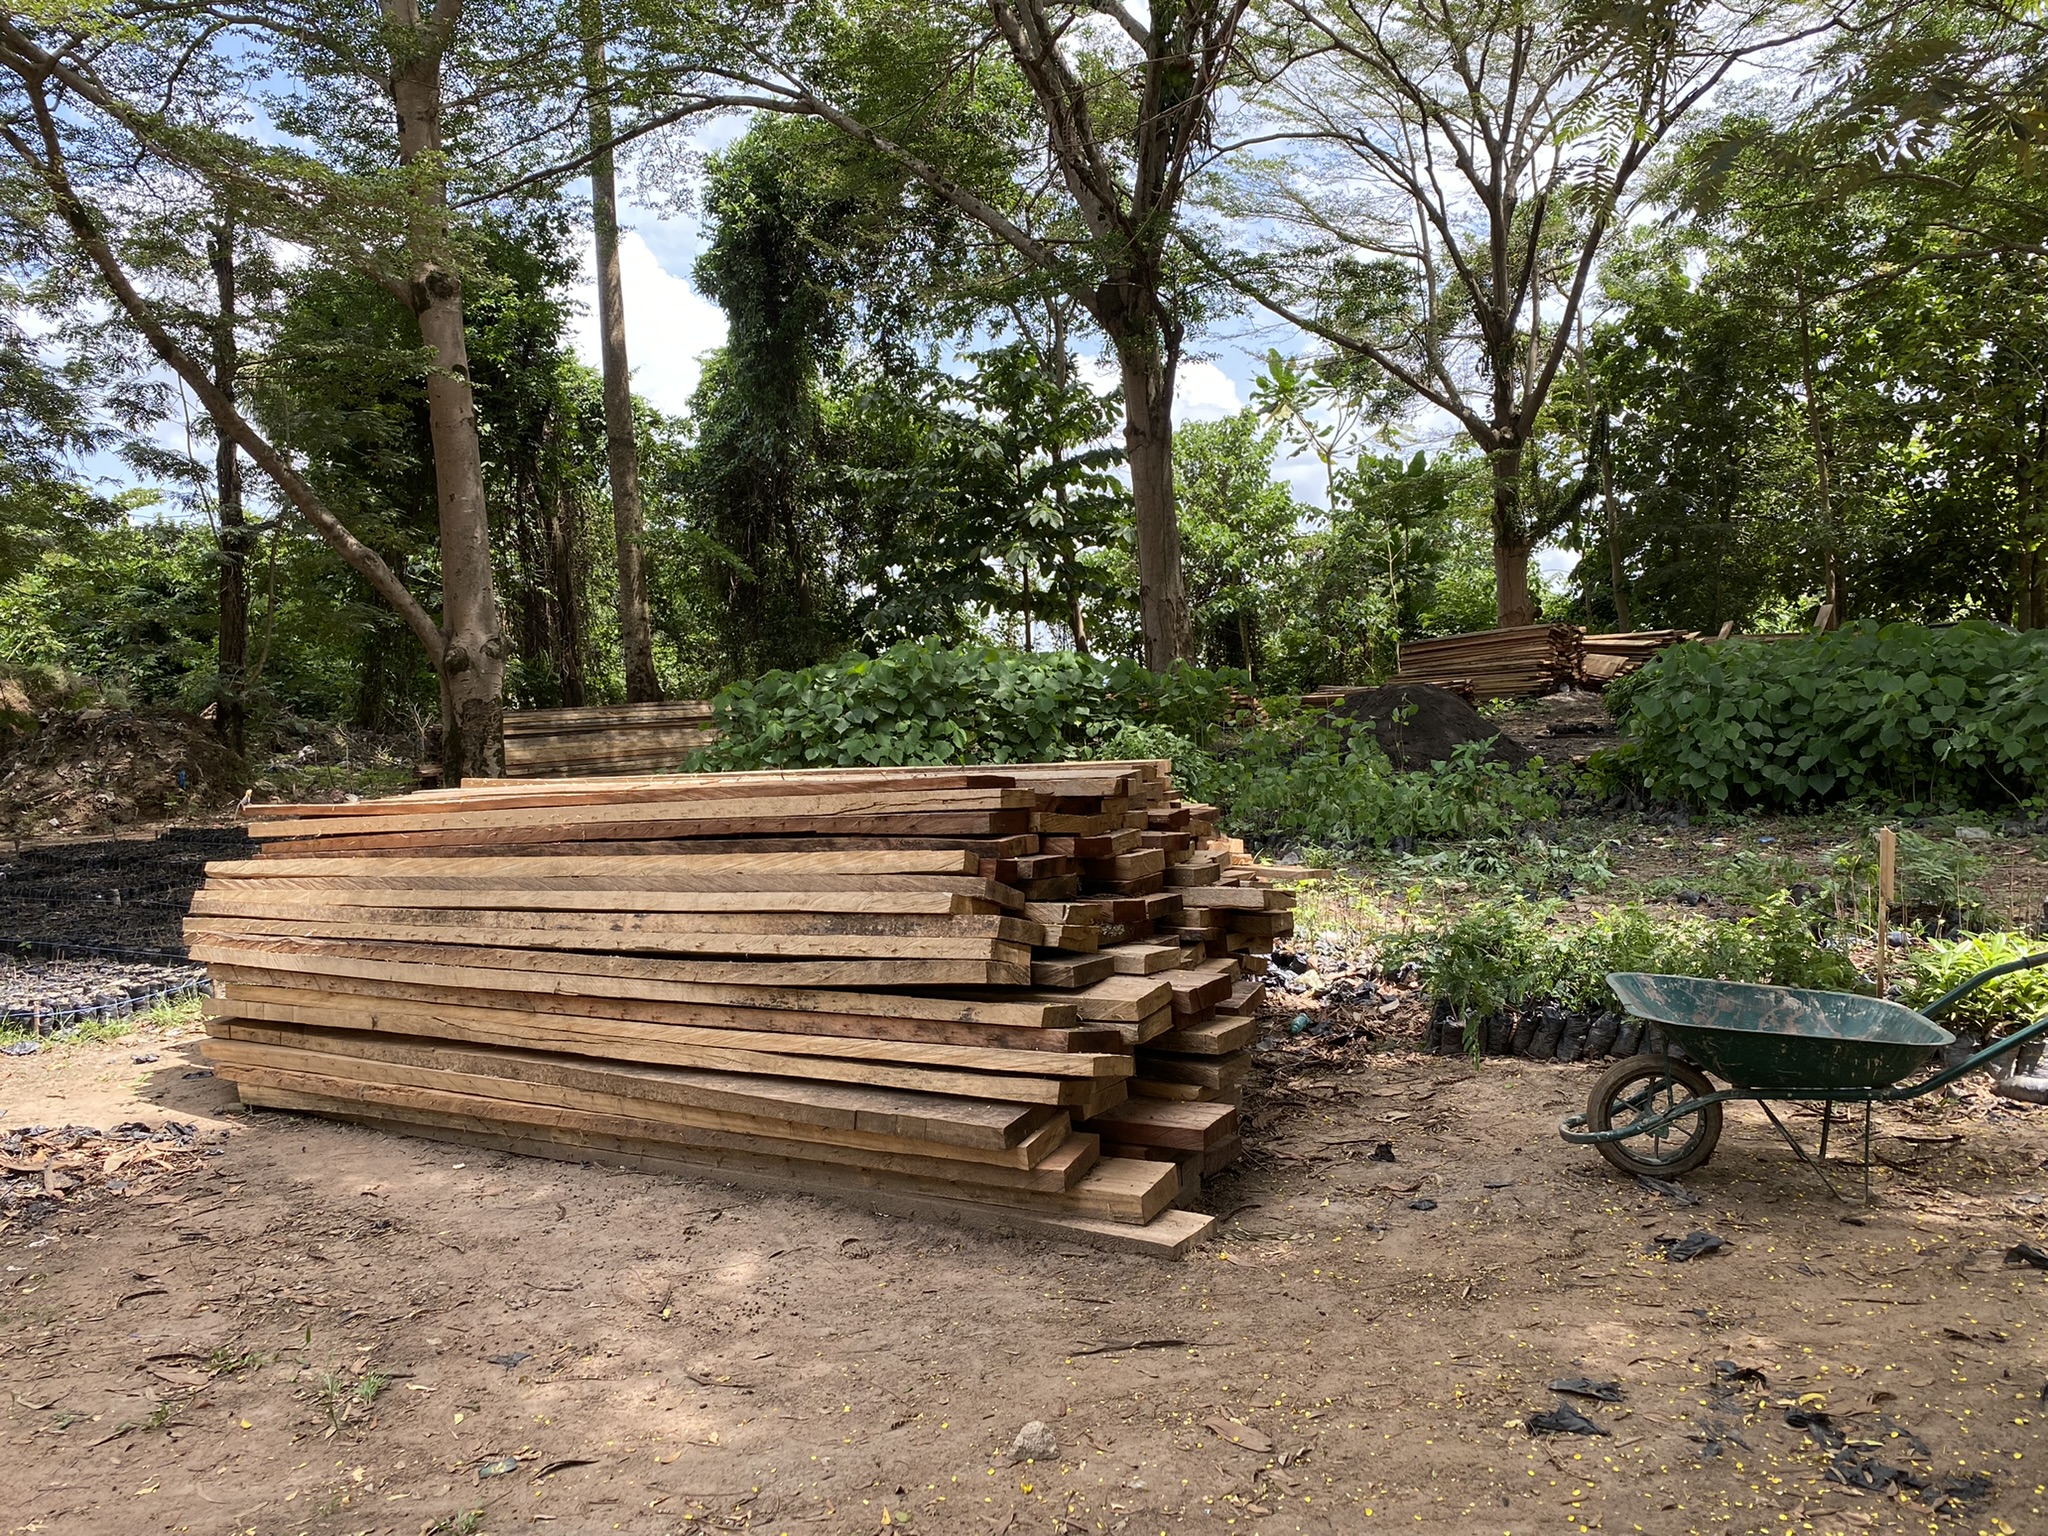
[0,0,506,776]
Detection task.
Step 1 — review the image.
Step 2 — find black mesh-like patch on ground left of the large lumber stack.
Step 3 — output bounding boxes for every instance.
[0,827,250,1034]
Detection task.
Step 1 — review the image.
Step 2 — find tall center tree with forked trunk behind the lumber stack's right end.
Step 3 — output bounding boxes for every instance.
[696,0,1249,668]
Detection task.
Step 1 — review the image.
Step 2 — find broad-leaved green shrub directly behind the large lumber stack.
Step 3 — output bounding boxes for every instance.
[690,641,1247,770]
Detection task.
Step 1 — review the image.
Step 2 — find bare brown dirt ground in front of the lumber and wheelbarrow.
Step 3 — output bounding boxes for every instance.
[0,1011,2048,1536]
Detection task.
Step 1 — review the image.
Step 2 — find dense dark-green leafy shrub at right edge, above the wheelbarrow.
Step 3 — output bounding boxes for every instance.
[1608,623,2048,807]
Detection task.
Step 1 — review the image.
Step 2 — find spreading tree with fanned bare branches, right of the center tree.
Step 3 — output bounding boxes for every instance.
[1227,0,1798,625]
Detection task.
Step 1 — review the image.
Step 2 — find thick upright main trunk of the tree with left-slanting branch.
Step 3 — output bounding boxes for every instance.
[383,0,506,784]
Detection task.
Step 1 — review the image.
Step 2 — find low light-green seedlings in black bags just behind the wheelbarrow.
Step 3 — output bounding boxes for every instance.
[1419,893,1860,1030]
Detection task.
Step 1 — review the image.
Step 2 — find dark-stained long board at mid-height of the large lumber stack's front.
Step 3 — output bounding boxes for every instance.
[186,920,1030,989]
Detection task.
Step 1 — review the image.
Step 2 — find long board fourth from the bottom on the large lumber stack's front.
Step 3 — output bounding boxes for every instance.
[207,1018,1071,1155]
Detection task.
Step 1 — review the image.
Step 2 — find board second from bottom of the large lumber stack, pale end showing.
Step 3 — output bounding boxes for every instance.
[232,1090,1180,1227]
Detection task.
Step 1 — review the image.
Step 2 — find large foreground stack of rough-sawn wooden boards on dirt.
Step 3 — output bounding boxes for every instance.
[186,762,1292,1253]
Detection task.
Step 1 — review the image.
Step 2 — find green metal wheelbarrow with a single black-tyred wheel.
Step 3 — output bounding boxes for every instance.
[1559,950,2048,1202]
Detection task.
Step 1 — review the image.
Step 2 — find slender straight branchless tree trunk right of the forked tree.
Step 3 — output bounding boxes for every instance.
[582,0,662,705]
